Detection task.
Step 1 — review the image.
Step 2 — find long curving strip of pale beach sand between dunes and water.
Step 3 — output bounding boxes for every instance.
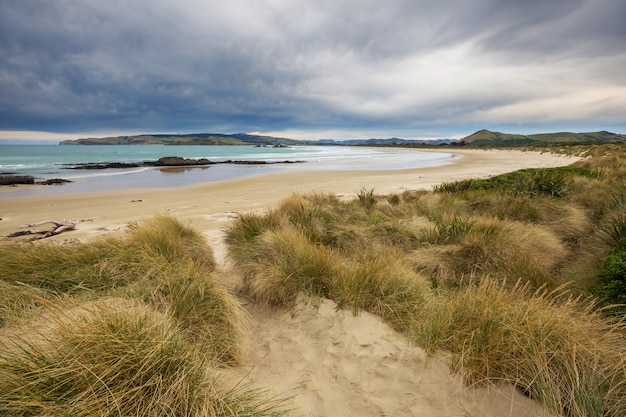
[0,149,579,241]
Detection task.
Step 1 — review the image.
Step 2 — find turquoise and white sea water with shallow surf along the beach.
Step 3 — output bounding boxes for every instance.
[0,145,455,199]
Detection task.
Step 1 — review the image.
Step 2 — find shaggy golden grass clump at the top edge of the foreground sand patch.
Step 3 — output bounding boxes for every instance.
[226,203,430,330]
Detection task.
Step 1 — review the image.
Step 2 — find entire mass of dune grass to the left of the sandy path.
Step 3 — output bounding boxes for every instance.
[0,216,286,416]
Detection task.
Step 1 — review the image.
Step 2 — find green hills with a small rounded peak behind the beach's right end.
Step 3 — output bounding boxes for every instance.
[456,129,626,146]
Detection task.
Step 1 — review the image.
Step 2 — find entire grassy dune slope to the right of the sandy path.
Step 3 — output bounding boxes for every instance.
[226,145,626,417]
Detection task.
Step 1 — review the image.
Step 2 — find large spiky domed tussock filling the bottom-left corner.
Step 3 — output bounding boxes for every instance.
[0,300,280,417]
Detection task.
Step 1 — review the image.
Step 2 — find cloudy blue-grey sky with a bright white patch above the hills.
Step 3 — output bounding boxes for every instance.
[0,0,626,141]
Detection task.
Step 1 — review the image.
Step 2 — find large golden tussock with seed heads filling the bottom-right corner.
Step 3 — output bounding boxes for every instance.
[416,280,626,416]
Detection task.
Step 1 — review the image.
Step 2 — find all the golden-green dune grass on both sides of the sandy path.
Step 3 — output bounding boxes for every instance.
[0,144,626,417]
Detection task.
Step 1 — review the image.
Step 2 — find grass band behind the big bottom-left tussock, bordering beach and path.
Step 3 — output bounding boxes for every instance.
[0,215,245,362]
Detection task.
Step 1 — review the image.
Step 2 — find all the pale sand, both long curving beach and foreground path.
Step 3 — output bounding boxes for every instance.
[0,150,575,417]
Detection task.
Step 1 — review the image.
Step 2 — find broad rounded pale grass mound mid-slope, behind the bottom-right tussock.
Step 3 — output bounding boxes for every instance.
[409,217,567,287]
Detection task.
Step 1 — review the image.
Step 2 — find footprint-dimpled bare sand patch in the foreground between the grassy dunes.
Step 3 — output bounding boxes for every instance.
[223,297,550,417]
